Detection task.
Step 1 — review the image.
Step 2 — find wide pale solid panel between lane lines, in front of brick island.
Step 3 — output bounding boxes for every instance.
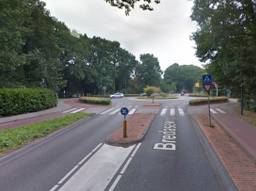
[60,144,134,191]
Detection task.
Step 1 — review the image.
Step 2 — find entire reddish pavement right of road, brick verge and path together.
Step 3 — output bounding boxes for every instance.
[194,103,256,191]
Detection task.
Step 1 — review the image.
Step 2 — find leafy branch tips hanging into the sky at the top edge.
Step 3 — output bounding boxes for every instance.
[105,0,160,15]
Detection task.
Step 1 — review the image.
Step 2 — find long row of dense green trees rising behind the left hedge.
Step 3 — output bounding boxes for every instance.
[0,0,163,96]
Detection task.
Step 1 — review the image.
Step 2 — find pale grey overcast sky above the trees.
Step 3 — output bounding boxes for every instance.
[43,0,202,70]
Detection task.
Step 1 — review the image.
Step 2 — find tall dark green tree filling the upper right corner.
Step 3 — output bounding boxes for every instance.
[191,0,256,99]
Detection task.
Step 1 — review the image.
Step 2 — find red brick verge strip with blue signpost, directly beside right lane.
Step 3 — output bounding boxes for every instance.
[194,114,256,191]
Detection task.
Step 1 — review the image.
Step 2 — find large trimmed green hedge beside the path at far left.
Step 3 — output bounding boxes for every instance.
[0,88,57,116]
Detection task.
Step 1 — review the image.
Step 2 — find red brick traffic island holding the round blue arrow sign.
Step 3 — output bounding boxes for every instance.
[106,113,156,147]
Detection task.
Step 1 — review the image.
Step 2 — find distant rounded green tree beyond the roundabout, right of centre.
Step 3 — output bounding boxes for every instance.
[164,63,203,92]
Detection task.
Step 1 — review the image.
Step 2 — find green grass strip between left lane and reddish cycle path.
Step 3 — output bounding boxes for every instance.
[0,112,91,153]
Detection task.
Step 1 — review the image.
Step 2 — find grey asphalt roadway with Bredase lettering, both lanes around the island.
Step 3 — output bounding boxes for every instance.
[0,98,232,191]
